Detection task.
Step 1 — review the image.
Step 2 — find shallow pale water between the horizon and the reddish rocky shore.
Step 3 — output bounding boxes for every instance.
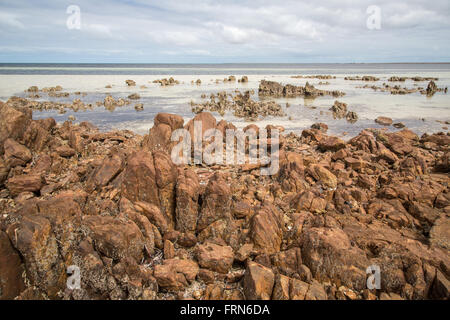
[0,64,450,137]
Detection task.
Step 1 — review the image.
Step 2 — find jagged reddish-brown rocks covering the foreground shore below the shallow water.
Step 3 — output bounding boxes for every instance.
[0,96,450,300]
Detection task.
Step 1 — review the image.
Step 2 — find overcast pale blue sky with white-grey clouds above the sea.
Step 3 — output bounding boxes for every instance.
[0,0,450,63]
